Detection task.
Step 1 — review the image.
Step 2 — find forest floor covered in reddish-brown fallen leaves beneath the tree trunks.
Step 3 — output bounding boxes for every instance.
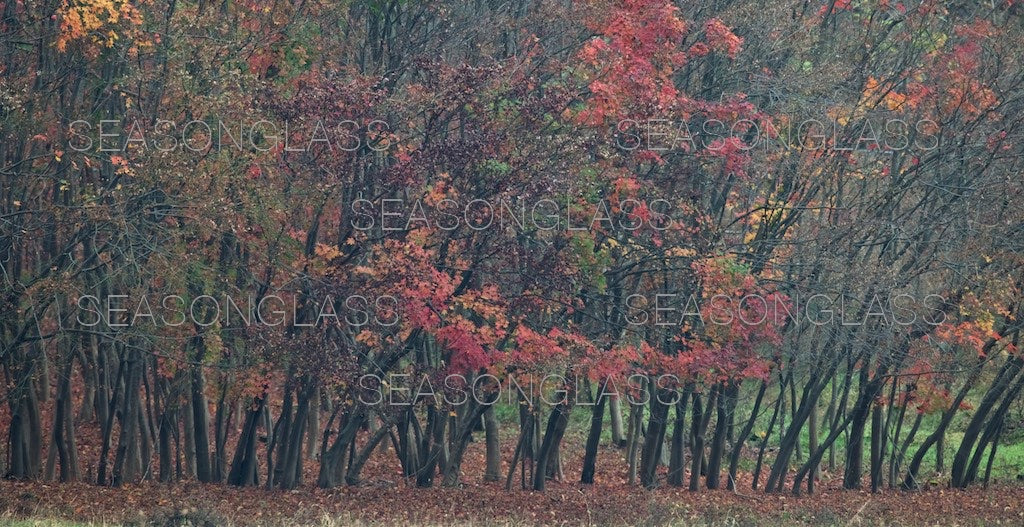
[0,433,1024,527]
